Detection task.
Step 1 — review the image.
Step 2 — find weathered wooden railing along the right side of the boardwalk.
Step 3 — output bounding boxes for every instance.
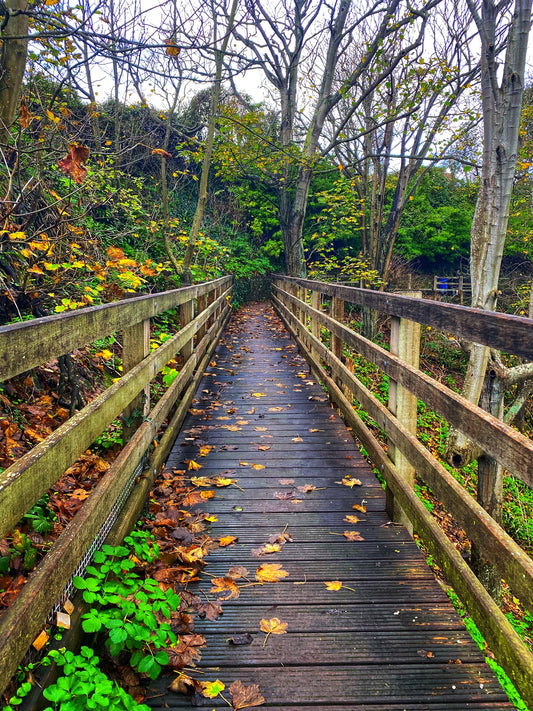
[273,276,533,708]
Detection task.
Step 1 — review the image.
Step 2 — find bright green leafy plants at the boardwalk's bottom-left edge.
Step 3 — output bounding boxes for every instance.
[2,531,172,711]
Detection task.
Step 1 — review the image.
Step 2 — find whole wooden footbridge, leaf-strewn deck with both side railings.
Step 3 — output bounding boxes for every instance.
[0,277,533,711]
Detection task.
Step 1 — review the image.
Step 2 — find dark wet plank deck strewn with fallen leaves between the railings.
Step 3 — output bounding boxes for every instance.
[148,304,514,711]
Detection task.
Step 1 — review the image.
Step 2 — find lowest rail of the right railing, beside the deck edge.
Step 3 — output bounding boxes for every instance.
[280,294,533,705]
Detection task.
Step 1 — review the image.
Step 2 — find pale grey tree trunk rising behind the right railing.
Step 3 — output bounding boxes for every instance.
[447,0,531,466]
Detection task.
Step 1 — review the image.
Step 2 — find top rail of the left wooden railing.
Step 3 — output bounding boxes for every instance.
[0,277,232,380]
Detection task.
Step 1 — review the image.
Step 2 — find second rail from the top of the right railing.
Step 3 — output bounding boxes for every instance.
[278,284,533,487]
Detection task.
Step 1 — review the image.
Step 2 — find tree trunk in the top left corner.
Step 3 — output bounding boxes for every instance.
[0,0,29,147]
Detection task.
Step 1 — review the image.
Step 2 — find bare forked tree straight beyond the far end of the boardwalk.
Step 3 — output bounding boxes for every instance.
[235,0,438,276]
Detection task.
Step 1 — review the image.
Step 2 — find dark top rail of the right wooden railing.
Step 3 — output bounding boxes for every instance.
[274,277,533,360]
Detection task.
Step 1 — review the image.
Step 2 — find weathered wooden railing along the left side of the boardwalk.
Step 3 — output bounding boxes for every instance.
[0,277,232,693]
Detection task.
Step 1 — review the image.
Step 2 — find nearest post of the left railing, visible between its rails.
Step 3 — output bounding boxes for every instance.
[122,319,150,444]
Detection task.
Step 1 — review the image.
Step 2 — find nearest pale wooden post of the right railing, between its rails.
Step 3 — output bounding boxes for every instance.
[386,291,422,534]
